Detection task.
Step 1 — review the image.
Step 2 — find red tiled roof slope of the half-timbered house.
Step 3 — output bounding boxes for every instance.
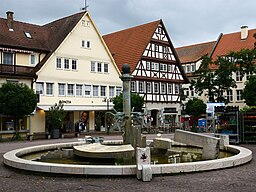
[103,20,161,72]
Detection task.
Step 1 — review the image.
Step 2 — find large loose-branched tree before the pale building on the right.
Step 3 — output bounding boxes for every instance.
[192,49,256,104]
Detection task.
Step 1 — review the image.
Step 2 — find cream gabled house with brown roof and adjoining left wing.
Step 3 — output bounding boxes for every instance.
[0,12,122,138]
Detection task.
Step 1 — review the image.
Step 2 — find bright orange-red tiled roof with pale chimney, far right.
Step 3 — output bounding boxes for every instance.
[212,29,256,61]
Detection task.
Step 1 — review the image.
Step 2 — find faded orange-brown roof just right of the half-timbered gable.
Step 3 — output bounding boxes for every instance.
[176,41,216,63]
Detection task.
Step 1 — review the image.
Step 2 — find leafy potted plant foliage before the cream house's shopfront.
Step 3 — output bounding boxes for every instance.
[48,101,66,129]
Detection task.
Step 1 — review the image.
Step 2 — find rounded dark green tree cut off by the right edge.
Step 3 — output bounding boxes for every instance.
[243,75,256,106]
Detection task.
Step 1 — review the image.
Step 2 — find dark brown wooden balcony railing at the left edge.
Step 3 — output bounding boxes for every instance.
[0,64,35,77]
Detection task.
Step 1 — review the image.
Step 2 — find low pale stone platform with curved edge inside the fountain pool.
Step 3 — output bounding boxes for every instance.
[73,143,135,159]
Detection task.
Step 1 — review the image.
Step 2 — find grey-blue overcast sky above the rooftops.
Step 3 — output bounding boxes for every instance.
[0,0,256,47]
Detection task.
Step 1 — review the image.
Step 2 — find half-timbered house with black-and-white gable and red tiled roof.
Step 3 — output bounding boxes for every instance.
[103,20,187,126]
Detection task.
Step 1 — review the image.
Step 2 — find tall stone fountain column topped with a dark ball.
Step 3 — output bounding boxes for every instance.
[120,64,135,147]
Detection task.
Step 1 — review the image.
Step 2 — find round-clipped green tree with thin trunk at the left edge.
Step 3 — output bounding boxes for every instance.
[0,82,37,138]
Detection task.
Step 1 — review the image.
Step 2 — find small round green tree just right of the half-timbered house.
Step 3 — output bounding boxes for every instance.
[185,98,206,117]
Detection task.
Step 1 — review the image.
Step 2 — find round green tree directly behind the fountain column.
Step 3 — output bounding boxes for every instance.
[113,93,144,112]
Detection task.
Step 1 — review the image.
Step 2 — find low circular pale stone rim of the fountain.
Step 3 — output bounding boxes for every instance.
[3,142,252,175]
